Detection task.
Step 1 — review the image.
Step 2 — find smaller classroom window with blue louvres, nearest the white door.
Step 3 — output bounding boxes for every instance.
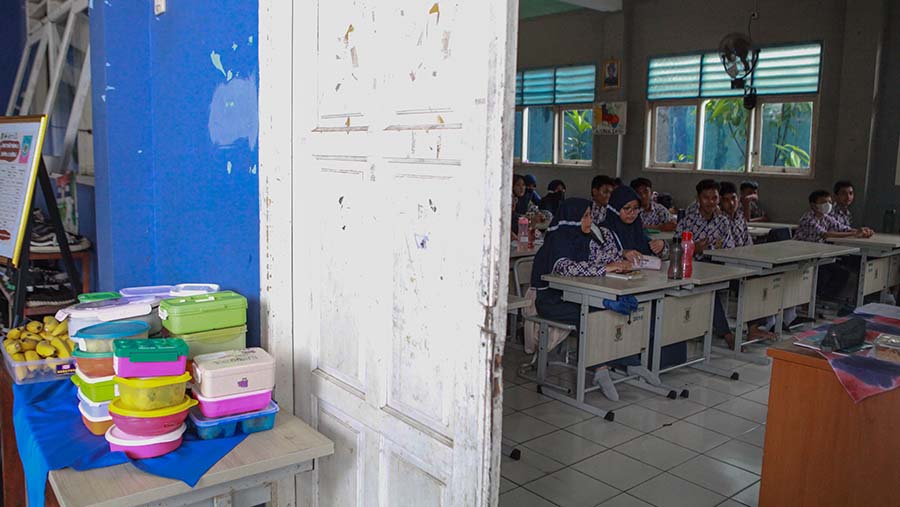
[513,65,597,165]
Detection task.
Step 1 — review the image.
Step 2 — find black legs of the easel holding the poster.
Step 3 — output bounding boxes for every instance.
[12,158,81,326]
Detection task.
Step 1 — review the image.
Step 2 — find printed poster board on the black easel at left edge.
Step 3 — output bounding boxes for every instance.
[0,116,47,265]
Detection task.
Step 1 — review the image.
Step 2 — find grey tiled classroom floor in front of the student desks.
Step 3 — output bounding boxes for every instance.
[500,349,771,507]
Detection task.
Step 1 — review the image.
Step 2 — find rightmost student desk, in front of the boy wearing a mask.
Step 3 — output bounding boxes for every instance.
[827,234,900,306]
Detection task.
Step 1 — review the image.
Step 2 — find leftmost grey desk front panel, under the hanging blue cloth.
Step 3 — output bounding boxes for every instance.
[585,303,650,366]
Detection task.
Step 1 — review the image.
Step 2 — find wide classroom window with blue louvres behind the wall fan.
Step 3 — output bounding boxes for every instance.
[645,43,822,175]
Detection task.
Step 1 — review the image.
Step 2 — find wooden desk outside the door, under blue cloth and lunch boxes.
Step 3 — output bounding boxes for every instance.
[49,414,334,507]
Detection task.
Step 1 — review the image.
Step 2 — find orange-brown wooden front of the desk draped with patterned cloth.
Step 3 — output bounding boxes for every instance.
[759,342,900,507]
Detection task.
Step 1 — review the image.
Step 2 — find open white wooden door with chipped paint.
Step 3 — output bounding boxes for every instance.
[282,0,516,506]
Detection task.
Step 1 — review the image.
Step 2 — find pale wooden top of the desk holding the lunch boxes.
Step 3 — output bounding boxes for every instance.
[50,414,334,507]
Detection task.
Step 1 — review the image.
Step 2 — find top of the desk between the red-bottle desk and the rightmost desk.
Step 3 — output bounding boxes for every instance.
[709,240,859,265]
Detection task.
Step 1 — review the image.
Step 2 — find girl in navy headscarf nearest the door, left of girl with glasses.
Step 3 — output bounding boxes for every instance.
[531,198,632,400]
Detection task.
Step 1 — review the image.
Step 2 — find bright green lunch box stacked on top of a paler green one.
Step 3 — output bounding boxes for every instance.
[159,290,247,335]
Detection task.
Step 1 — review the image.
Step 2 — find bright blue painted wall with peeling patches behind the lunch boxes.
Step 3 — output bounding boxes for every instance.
[91,0,259,343]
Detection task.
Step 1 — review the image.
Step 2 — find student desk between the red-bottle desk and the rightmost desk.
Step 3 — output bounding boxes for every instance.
[708,240,859,363]
